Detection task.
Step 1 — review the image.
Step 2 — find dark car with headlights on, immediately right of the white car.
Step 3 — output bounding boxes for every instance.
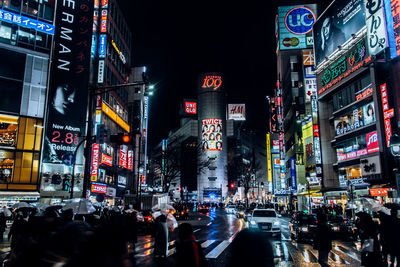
[289,212,318,243]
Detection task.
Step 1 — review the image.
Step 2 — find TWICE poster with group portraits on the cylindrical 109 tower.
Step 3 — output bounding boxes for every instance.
[201,119,222,151]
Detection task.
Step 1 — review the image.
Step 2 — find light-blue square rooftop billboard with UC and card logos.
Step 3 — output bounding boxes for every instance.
[276,5,316,50]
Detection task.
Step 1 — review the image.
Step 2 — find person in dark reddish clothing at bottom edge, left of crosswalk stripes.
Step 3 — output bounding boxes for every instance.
[176,223,207,267]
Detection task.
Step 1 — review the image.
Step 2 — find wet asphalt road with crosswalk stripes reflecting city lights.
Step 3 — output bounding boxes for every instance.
[136,209,360,267]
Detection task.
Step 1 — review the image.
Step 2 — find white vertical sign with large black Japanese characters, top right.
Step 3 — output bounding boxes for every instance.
[364,0,387,55]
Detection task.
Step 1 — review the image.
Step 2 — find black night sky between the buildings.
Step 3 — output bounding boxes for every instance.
[119,0,331,151]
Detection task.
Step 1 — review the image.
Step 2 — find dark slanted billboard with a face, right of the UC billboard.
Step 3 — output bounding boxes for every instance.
[313,0,365,66]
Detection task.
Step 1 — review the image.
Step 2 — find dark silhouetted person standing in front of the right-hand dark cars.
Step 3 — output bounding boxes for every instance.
[314,213,332,267]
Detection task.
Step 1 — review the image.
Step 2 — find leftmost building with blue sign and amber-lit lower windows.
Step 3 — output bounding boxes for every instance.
[0,0,55,205]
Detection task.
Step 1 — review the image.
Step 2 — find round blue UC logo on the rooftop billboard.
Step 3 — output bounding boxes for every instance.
[285,7,315,35]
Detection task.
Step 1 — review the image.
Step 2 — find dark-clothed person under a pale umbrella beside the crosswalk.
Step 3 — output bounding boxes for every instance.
[154,214,168,261]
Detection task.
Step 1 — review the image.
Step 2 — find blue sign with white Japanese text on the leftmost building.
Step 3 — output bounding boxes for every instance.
[0,10,55,35]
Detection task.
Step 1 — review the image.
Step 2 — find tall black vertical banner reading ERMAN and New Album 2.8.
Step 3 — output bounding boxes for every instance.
[43,1,93,164]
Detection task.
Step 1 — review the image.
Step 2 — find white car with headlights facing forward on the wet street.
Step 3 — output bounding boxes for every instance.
[249,209,281,237]
